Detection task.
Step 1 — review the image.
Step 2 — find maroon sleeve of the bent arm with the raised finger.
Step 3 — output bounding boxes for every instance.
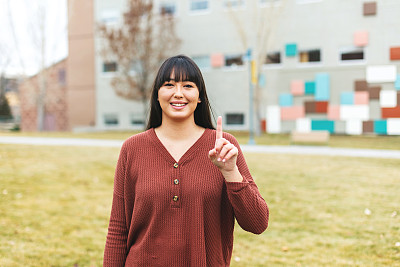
[226,137,269,234]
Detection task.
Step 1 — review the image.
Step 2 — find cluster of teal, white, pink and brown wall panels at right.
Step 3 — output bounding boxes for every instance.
[267,65,400,135]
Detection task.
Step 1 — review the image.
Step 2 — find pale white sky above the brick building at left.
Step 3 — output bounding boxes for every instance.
[0,0,68,76]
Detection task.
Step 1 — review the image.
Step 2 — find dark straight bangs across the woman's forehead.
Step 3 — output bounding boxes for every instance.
[157,58,202,87]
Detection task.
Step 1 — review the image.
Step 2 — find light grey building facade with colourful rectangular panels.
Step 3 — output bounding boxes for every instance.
[69,0,400,135]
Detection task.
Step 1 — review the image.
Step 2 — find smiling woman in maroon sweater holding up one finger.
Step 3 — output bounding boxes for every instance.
[104,55,268,267]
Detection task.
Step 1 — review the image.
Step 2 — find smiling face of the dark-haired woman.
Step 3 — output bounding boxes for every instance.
[158,72,200,121]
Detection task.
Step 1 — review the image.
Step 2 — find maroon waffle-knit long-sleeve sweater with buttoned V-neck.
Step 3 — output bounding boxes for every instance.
[103,129,269,267]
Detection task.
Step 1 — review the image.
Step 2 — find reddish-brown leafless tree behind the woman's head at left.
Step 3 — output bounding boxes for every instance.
[99,0,181,119]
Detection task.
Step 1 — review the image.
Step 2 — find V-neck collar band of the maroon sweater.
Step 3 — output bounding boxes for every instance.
[149,128,211,164]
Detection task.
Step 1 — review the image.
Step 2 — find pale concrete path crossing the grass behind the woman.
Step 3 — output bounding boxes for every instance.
[0,136,400,159]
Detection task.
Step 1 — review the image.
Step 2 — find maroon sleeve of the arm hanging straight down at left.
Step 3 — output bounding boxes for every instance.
[103,143,128,267]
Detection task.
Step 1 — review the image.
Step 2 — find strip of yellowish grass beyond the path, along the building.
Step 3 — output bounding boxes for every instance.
[0,131,400,150]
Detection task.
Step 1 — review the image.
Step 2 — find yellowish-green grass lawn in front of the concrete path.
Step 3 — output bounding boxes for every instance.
[0,146,400,267]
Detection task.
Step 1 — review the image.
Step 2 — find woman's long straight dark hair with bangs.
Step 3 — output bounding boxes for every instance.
[146,55,215,130]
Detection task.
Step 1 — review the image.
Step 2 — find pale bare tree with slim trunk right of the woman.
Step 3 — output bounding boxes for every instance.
[227,0,287,135]
